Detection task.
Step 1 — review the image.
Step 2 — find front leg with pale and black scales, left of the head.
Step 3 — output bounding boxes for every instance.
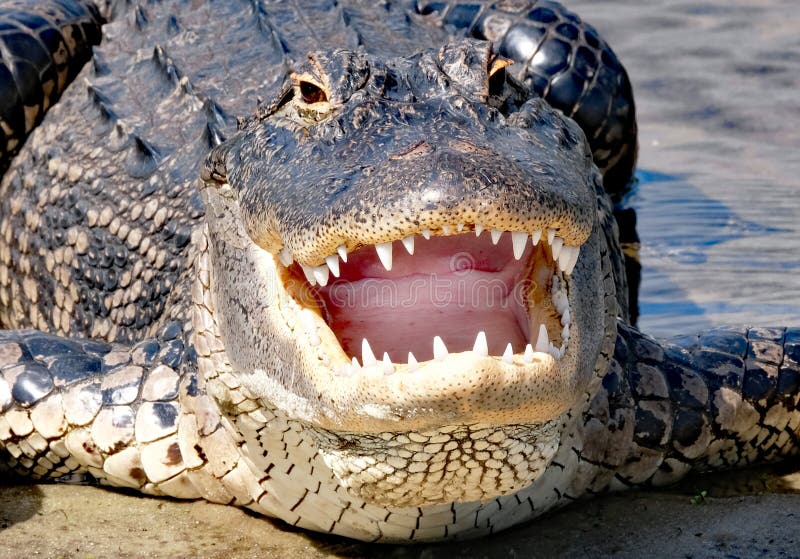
[0,323,203,498]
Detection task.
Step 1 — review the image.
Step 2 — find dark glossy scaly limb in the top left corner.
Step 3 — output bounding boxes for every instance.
[0,0,103,176]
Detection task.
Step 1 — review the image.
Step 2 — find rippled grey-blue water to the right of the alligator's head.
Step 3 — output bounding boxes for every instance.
[567,0,800,336]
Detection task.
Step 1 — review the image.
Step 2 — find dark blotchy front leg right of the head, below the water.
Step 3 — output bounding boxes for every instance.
[580,325,800,488]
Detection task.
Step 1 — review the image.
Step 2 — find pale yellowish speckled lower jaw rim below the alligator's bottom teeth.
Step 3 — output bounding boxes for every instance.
[266,236,580,433]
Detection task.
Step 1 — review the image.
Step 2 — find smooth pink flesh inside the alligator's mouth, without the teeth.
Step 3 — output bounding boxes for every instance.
[318,234,533,363]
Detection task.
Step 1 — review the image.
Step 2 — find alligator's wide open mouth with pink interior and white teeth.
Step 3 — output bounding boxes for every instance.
[278,224,580,374]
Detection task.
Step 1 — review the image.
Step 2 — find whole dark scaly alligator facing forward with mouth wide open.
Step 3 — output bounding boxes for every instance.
[0,0,800,542]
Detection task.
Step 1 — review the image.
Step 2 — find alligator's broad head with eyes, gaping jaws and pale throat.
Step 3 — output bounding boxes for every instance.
[197,41,619,506]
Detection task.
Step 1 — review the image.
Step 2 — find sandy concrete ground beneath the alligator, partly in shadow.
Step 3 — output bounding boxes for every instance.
[0,471,800,559]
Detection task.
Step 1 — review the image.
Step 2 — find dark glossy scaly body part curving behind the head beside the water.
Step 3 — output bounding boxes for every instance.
[418,1,637,197]
